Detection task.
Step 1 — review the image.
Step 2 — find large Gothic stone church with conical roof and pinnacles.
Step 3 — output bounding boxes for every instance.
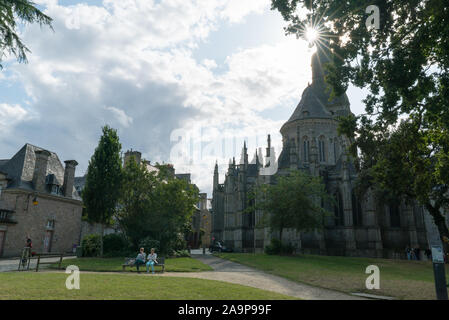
[212,48,428,258]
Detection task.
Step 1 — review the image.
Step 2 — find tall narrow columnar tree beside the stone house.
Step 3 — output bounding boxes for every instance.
[82,125,122,256]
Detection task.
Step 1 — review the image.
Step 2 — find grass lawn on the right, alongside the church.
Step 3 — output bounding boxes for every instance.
[217,253,449,299]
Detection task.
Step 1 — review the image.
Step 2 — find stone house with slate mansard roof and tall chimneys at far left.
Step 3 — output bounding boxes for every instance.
[0,144,82,257]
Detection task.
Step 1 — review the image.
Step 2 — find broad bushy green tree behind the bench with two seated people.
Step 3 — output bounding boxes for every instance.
[117,161,199,254]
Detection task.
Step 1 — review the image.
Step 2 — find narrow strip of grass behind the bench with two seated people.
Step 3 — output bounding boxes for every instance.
[50,258,213,272]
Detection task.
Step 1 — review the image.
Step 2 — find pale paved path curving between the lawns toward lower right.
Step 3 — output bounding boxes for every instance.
[161,254,364,300]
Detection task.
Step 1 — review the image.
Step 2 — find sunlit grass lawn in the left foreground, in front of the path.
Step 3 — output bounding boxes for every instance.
[0,272,294,300]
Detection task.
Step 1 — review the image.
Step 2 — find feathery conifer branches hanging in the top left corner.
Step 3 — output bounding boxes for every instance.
[0,0,52,69]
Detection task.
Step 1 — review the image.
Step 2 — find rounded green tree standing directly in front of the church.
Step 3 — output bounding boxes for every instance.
[254,170,332,245]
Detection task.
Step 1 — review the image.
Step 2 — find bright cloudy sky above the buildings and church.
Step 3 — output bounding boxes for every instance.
[0,0,364,197]
